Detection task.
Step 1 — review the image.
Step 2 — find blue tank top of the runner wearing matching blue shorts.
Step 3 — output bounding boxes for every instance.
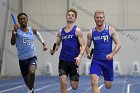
[92,25,112,60]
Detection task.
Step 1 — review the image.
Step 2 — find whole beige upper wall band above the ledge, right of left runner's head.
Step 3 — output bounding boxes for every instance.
[22,0,140,29]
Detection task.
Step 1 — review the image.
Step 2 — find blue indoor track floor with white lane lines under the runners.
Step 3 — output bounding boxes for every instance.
[0,76,140,93]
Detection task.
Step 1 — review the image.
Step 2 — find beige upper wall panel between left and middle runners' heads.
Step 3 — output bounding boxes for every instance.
[23,0,67,30]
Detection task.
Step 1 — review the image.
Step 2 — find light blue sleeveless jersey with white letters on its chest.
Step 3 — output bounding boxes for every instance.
[16,27,36,60]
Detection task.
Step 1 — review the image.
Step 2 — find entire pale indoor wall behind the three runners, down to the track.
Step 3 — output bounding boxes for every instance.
[0,0,140,76]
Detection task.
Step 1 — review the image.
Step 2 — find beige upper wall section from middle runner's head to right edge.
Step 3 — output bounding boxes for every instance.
[69,0,140,29]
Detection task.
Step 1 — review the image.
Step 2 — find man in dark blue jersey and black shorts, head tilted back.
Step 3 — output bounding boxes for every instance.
[50,9,85,93]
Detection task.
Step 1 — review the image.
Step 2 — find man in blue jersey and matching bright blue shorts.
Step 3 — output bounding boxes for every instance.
[86,10,121,93]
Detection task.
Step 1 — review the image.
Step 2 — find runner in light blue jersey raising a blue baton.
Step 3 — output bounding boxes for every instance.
[11,13,47,93]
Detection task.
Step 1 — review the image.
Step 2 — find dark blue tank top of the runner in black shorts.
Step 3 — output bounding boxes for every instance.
[59,26,80,62]
